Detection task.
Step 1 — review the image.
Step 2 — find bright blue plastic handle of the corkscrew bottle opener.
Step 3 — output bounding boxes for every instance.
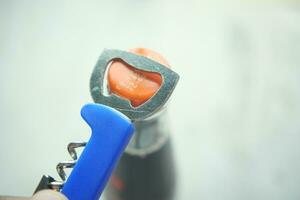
[62,104,134,200]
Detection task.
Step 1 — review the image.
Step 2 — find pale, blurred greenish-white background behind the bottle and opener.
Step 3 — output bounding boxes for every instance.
[0,0,300,200]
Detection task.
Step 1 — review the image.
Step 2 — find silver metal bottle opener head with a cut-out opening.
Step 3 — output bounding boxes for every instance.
[90,49,179,121]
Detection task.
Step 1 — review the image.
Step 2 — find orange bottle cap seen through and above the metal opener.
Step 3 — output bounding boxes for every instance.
[108,48,169,107]
